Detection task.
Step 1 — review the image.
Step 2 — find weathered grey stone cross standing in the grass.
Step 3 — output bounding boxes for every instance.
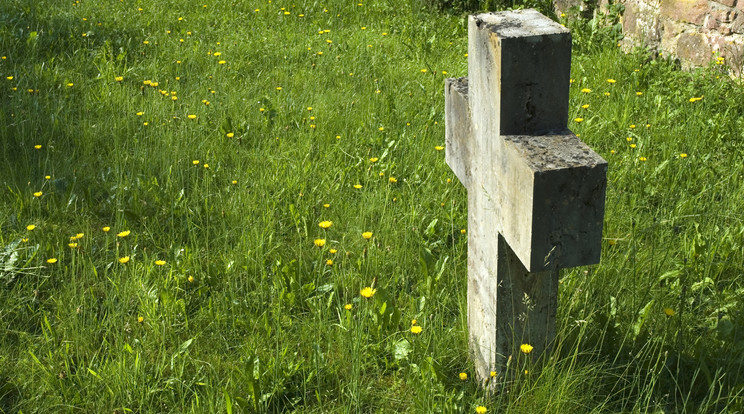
[445,10,607,381]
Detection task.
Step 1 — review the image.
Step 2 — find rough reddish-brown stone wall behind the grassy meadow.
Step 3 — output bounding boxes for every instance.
[555,0,744,73]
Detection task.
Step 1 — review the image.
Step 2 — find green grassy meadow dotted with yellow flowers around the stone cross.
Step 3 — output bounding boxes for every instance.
[0,0,744,413]
